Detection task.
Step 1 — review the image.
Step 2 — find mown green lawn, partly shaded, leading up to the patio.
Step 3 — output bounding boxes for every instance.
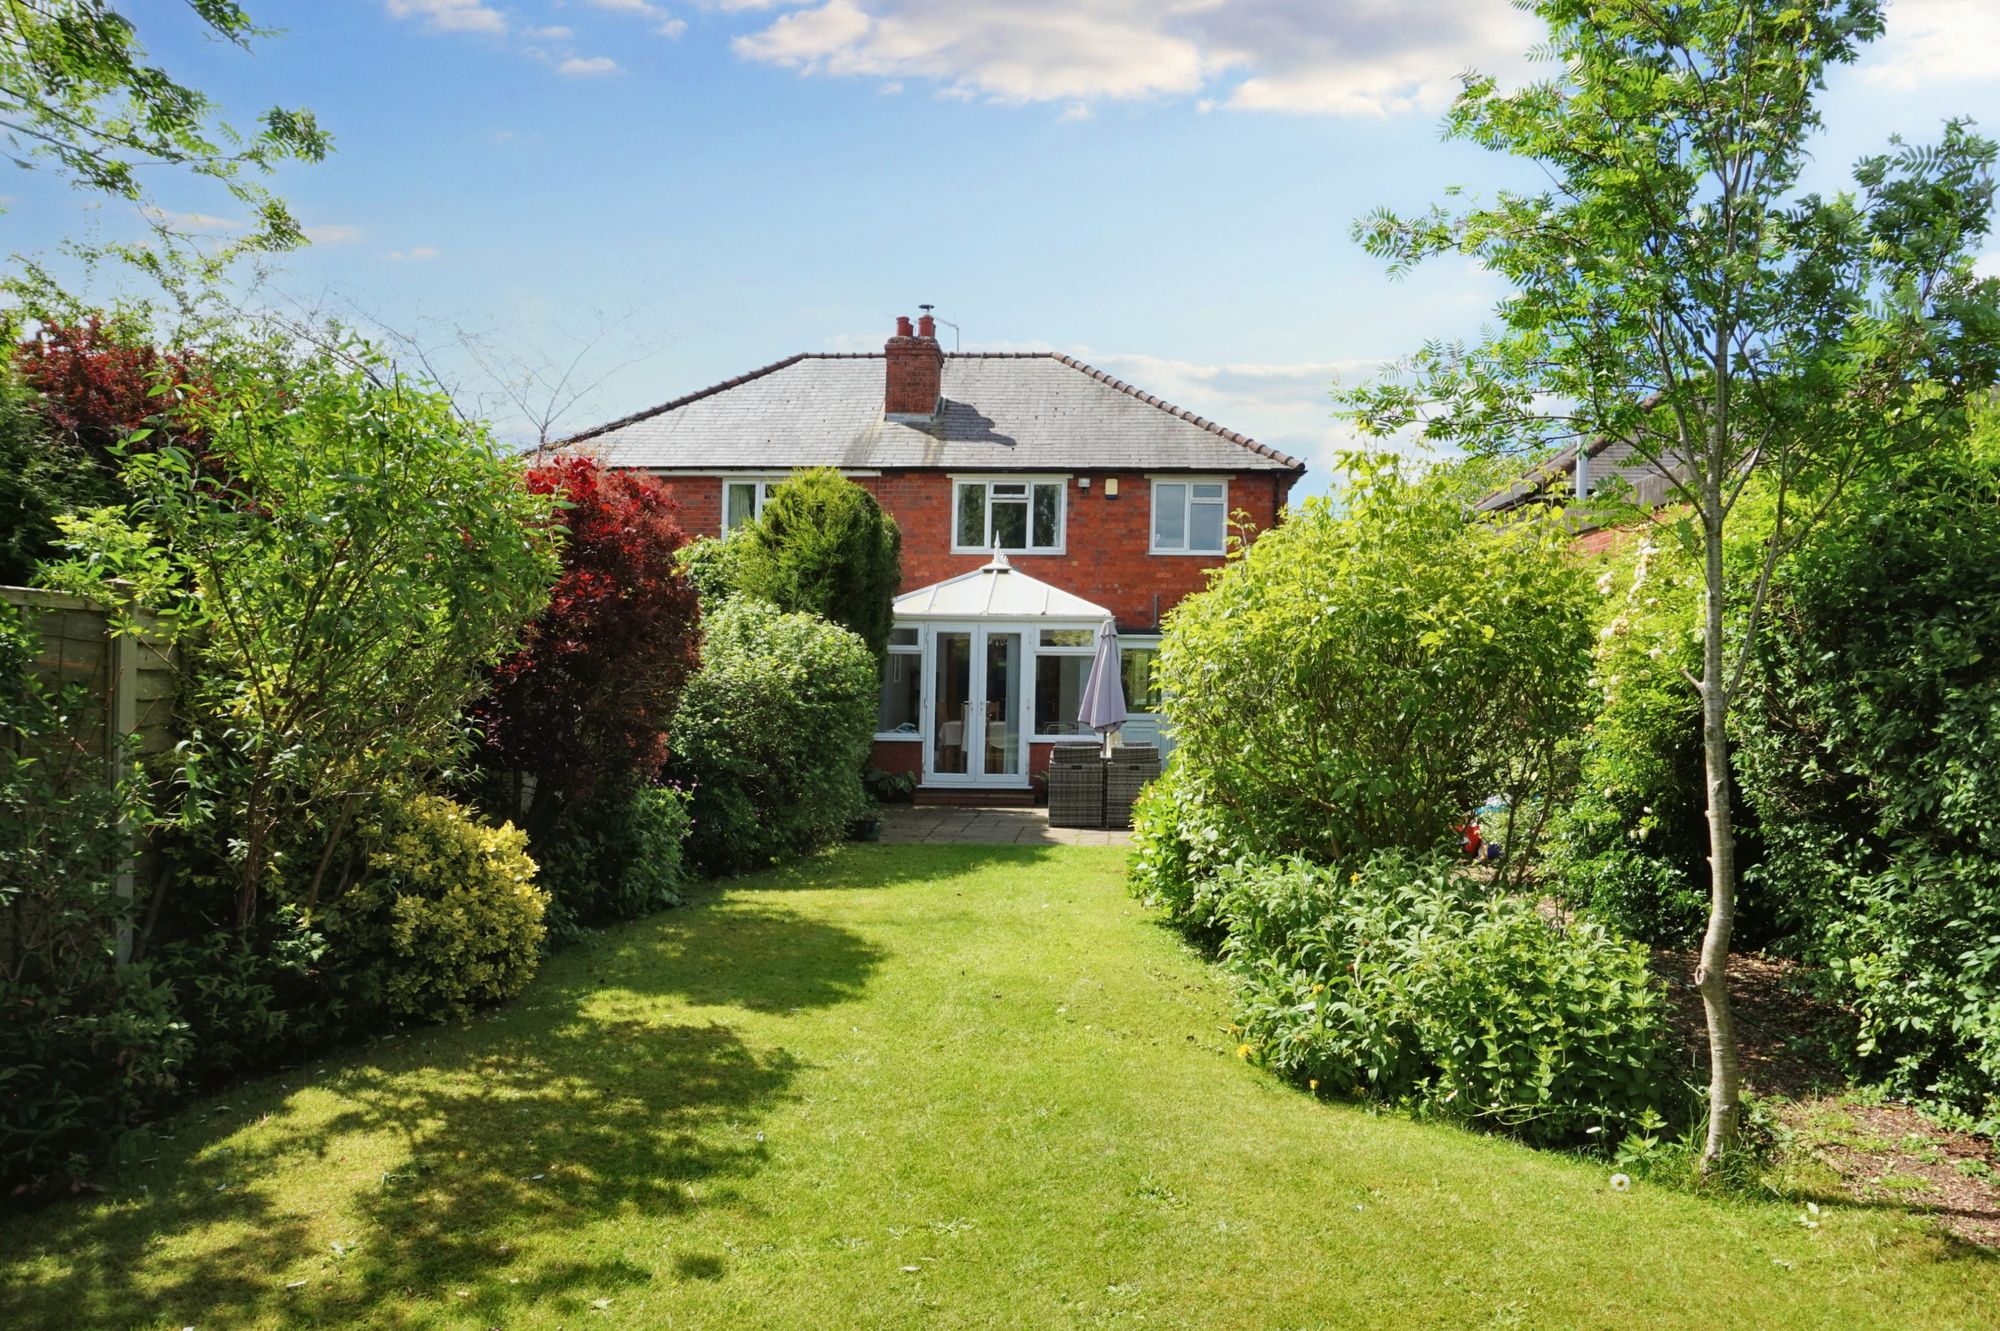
[0,845,2000,1331]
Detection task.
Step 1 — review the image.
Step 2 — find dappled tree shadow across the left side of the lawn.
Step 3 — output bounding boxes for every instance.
[0,901,880,1331]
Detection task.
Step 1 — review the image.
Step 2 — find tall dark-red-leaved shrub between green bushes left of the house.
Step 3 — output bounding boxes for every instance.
[472,458,700,835]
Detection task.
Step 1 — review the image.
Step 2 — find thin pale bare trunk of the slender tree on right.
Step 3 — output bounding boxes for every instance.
[1694,515,1742,1173]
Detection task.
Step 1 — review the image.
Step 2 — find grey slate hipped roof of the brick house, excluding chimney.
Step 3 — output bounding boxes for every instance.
[558,352,1306,474]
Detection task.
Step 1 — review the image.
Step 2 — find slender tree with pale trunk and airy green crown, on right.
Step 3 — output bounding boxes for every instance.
[1350,0,2000,1167]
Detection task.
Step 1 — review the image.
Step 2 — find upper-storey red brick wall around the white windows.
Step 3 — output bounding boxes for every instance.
[644,470,1294,634]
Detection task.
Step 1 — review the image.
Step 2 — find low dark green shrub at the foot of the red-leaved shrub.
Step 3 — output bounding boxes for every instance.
[540,785,692,939]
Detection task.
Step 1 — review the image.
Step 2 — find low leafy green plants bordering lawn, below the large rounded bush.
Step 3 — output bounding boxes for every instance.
[1218,853,1692,1145]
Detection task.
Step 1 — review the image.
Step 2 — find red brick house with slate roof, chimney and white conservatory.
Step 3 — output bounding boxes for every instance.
[564,316,1304,801]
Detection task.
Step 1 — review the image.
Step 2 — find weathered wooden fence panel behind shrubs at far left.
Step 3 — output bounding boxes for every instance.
[0,588,174,963]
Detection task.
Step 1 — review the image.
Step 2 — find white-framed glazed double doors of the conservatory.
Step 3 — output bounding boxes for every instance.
[924,624,1028,785]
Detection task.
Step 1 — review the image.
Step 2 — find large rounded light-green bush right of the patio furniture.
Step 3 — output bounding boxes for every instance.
[1144,458,1590,879]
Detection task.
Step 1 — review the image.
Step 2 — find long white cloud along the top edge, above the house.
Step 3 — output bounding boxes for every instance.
[736,0,1528,116]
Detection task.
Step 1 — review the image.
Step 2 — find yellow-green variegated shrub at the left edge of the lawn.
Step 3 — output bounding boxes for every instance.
[324,795,548,1019]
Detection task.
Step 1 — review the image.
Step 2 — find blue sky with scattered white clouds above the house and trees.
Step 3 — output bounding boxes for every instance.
[0,0,2000,490]
